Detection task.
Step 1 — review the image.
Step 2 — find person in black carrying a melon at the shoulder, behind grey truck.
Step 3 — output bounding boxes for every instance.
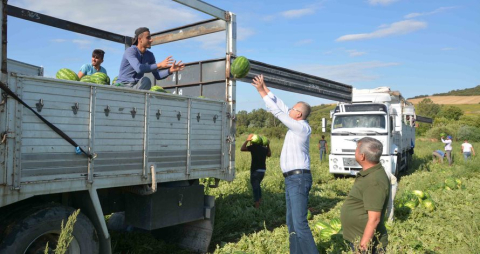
[240,134,272,208]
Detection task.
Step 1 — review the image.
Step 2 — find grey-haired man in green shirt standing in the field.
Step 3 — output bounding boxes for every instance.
[340,137,390,253]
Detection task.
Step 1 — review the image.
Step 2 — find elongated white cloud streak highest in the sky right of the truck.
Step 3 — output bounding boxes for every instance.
[336,20,427,41]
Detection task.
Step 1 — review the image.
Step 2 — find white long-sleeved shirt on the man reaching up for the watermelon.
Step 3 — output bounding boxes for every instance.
[263,92,312,173]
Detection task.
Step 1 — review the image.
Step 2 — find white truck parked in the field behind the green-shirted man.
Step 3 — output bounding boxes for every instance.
[329,87,416,176]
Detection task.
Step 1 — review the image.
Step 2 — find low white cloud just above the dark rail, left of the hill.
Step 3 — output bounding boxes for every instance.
[299,61,399,84]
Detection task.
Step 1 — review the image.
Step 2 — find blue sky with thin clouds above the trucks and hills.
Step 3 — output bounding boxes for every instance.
[8,0,480,111]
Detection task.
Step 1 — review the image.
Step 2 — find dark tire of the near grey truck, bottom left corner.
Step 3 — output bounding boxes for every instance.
[0,204,99,254]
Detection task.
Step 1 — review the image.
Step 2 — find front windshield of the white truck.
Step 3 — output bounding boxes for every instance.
[333,115,386,129]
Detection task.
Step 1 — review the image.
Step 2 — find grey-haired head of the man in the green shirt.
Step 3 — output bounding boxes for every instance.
[355,137,383,166]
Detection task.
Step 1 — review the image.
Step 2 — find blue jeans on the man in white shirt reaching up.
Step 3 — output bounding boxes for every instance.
[285,174,318,254]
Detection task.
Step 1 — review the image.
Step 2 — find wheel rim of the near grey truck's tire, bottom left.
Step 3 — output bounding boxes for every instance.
[24,231,80,254]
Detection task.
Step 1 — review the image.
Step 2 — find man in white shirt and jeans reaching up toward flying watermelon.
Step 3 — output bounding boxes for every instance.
[252,75,318,254]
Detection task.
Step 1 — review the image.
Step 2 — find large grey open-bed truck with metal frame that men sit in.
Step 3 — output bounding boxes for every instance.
[0,0,352,254]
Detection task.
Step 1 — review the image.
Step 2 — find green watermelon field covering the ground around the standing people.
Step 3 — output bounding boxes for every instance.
[112,136,480,253]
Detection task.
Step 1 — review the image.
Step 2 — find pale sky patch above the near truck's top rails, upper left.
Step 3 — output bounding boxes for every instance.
[9,0,201,36]
